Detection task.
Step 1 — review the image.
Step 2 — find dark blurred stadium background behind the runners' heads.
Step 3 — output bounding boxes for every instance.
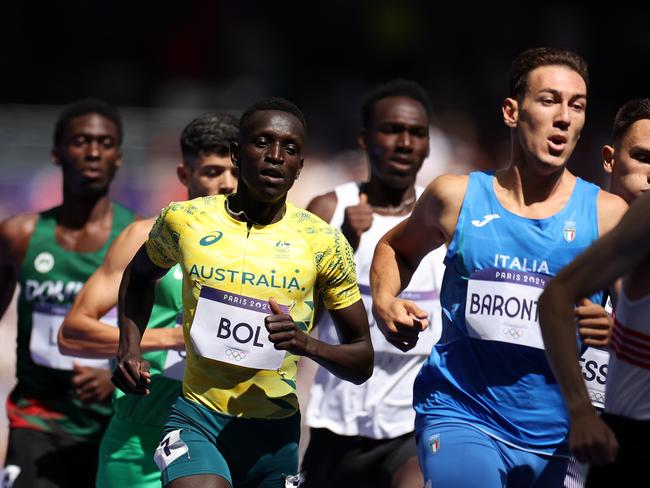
[0,0,650,458]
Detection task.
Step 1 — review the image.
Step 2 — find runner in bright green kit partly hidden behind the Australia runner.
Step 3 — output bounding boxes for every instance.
[59,113,238,488]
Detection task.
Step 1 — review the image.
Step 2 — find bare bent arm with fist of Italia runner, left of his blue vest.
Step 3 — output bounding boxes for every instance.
[370,175,468,350]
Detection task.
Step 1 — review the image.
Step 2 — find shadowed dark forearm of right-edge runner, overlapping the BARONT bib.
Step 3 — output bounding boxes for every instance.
[539,284,593,417]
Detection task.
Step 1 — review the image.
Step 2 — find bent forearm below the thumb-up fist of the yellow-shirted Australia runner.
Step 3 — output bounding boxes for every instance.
[305,336,374,385]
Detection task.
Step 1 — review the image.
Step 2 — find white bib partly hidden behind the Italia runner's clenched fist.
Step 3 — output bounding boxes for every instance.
[359,285,442,356]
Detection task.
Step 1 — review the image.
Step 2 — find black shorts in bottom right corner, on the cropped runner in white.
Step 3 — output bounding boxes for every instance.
[586,412,650,488]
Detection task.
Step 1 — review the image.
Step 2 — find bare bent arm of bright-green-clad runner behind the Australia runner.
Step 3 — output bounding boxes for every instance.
[58,220,184,358]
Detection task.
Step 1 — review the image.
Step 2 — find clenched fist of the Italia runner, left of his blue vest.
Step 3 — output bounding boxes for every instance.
[372,297,429,351]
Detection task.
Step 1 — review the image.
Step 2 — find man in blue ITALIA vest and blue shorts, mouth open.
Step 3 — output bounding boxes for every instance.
[371,48,627,487]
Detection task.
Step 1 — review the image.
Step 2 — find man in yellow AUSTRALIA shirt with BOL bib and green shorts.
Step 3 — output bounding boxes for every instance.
[113,99,373,488]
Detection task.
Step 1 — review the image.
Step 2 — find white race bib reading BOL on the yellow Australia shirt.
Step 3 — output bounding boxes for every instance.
[190,286,289,370]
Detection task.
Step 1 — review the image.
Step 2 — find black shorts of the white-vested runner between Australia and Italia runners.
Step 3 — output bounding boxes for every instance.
[300,429,418,488]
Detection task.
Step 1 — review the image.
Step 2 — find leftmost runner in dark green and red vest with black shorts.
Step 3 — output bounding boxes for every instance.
[0,99,134,488]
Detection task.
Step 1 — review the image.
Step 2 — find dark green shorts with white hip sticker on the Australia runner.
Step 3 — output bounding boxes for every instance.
[155,397,300,488]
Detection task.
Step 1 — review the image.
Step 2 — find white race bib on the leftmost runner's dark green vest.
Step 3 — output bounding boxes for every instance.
[29,303,110,371]
